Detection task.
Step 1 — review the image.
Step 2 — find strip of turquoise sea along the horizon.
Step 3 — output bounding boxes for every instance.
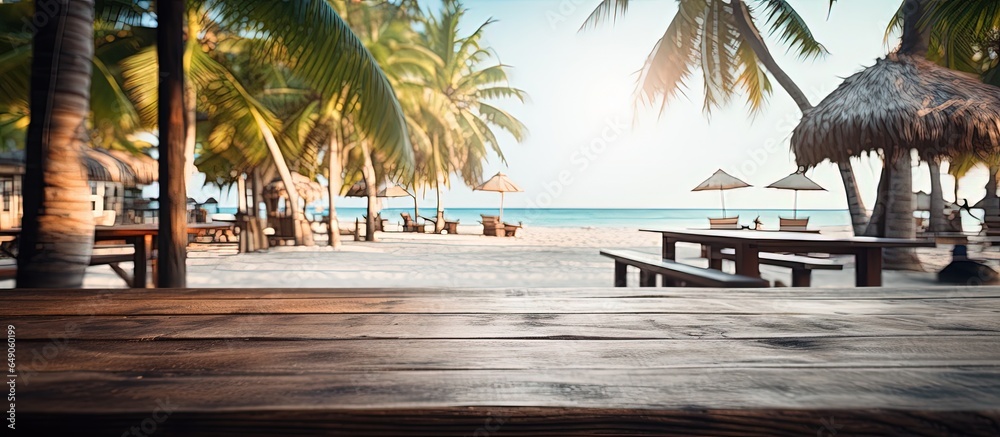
[219,208,851,228]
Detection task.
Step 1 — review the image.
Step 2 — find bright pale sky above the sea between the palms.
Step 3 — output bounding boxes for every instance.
[209,0,987,209]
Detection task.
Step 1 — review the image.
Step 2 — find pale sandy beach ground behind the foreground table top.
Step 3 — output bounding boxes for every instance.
[0,227,1000,288]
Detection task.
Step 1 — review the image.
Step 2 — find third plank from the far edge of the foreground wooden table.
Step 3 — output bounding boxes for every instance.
[4,313,1000,341]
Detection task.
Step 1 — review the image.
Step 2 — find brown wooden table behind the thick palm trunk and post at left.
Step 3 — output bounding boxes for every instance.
[0,223,232,288]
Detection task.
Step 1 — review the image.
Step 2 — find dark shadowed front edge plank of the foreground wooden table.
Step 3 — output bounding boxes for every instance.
[18,406,1000,437]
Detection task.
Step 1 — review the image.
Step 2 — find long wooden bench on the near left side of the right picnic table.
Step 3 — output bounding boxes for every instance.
[601,250,770,288]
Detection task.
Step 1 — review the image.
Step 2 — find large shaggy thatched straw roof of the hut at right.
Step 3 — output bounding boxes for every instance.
[791,54,1000,166]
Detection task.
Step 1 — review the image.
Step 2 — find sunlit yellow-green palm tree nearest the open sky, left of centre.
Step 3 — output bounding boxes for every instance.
[410,0,527,232]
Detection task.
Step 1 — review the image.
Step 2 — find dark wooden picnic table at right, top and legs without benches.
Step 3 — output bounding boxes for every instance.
[641,229,935,287]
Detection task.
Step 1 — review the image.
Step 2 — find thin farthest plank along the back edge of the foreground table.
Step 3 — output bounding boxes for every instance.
[0,286,1000,300]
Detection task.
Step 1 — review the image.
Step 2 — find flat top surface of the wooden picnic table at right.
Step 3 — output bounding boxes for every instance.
[640,228,935,248]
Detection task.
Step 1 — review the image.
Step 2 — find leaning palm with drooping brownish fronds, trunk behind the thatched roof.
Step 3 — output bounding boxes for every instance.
[580,0,867,234]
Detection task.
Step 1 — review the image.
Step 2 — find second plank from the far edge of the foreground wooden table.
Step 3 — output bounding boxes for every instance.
[2,296,1000,317]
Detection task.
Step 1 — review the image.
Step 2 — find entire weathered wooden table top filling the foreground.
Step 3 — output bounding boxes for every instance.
[9,287,1000,436]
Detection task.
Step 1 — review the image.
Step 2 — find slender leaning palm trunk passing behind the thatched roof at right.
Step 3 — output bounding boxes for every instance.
[733,0,868,235]
